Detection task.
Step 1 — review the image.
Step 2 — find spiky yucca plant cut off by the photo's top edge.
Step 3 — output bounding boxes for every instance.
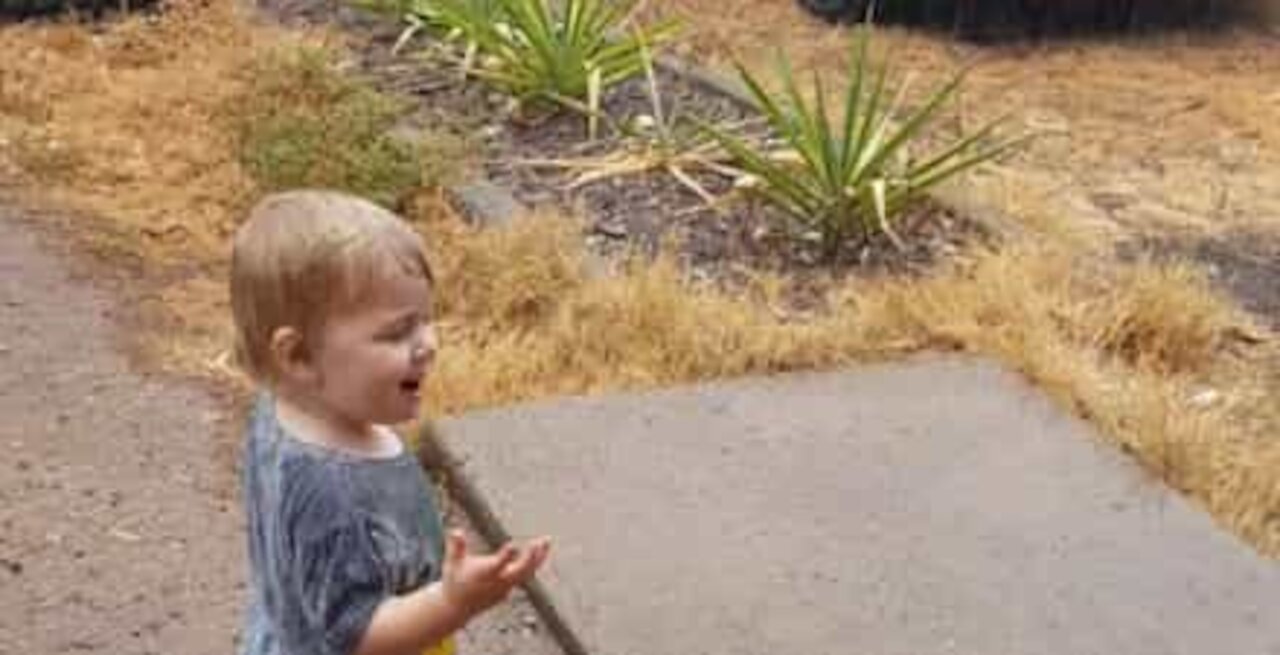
[399,0,675,132]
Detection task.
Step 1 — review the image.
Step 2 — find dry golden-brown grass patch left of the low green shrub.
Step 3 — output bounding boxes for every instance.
[0,3,312,265]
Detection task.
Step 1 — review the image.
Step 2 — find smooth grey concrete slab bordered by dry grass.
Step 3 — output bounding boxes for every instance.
[442,361,1280,655]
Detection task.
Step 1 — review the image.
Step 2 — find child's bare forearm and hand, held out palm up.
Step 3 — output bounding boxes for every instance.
[356,531,550,655]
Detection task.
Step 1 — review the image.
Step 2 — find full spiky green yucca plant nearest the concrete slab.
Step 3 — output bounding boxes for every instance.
[701,23,1024,257]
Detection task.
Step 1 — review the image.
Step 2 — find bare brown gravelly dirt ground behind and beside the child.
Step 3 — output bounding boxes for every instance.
[0,206,558,655]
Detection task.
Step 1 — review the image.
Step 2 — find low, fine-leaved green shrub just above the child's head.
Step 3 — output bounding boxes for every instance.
[238,49,422,206]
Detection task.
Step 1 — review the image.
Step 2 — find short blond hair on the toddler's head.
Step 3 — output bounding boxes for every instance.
[230,191,433,383]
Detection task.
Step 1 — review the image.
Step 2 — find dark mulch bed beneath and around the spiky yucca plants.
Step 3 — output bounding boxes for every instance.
[343,23,986,276]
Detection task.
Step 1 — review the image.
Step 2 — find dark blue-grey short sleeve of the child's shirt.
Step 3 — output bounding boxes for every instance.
[280,519,388,655]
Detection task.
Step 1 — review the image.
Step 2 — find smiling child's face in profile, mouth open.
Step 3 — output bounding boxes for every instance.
[311,271,436,430]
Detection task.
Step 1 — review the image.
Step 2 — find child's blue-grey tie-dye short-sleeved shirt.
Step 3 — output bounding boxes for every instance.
[239,394,443,655]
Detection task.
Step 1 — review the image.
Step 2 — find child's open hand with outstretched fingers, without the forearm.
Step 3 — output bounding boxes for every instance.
[440,530,550,615]
